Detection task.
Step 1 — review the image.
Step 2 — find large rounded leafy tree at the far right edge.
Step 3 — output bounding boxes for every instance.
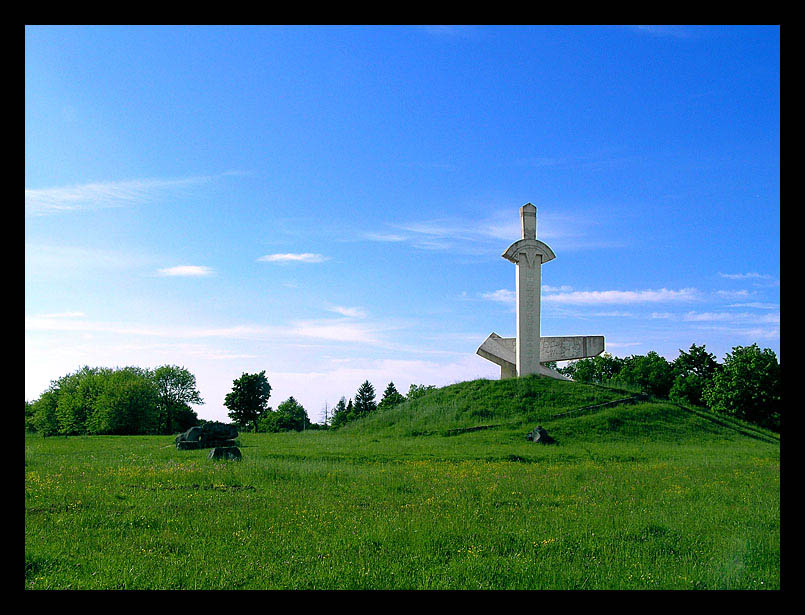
[703,344,782,429]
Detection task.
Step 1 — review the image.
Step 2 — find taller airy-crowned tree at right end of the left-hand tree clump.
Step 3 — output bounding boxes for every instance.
[152,365,204,434]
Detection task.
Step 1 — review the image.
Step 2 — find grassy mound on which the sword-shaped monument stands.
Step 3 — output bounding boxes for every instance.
[339,376,779,443]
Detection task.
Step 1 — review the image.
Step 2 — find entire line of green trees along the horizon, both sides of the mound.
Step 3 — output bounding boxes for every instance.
[25,344,782,436]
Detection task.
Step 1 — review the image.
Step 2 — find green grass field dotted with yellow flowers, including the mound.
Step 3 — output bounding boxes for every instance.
[25,378,780,589]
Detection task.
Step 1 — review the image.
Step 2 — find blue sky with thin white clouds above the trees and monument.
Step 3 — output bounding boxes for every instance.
[25,26,780,420]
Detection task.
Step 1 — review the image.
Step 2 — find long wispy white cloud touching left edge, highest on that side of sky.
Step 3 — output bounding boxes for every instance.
[25,171,238,215]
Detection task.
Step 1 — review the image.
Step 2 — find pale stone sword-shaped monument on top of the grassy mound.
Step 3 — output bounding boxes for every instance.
[476,203,604,380]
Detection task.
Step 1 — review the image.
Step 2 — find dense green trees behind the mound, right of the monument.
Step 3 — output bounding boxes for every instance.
[556,344,782,431]
